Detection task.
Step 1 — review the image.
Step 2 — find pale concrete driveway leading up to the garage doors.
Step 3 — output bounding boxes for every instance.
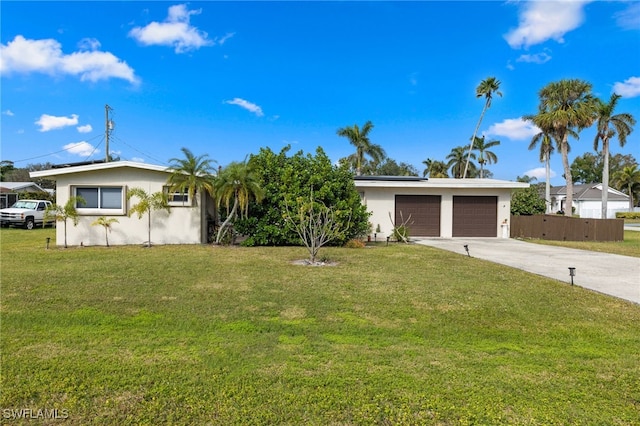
[413,238,640,304]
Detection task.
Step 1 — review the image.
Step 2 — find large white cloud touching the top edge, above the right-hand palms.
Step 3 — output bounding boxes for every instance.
[504,0,591,49]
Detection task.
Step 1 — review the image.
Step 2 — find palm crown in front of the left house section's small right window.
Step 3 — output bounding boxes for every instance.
[167,148,215,206]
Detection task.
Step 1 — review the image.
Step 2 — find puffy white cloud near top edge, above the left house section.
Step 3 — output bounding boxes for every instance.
[129,4,215,53]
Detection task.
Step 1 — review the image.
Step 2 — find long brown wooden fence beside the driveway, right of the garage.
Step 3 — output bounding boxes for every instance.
[510,215,624,241]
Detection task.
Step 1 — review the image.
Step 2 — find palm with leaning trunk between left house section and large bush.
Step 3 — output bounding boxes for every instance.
[215,160,263,244]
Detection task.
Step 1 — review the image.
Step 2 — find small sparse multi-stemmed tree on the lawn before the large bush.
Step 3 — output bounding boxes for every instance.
[284,193,350,264]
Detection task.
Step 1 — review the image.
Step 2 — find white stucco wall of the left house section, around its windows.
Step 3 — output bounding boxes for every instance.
[56,167,203,246]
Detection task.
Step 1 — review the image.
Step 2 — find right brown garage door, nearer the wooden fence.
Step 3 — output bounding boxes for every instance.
[453,196,498,237]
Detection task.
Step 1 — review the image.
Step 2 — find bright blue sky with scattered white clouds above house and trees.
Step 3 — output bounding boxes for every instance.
[0,0,640,184]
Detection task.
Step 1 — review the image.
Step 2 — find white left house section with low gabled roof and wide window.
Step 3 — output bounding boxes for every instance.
[31,161,215,246]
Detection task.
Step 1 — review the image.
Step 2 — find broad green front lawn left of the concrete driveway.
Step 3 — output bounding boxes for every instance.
[0,229,640,425]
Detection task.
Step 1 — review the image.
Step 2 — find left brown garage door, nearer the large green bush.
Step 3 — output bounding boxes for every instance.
[395,195,440,237]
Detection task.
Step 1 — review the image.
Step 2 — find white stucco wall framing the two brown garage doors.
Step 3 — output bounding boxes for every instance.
[356,179,511,240]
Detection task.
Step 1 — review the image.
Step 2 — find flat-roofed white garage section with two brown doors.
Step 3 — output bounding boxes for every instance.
[354,176,529,239]
